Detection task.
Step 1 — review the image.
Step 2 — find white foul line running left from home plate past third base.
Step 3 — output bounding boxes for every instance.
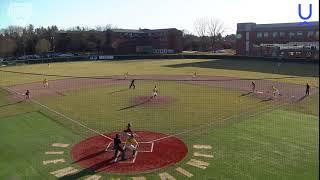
[4,87,113,141]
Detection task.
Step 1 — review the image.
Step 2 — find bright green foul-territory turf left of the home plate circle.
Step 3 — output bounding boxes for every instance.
[0,112,80,179]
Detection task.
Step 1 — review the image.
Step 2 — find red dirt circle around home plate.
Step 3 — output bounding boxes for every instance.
[71,131,188,174]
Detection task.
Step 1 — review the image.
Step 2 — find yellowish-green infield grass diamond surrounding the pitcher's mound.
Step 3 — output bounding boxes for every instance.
[36,81,272,134]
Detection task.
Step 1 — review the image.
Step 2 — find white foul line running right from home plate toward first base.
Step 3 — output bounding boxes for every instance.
[149,103,287,143]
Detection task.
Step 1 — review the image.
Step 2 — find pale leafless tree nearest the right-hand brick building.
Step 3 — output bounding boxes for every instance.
[207,19,225,49]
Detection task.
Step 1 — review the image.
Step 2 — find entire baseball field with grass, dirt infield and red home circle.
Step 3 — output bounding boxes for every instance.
[0,59,319,180]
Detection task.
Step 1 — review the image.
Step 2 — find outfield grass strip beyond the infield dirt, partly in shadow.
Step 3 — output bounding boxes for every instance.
[0,59,319,87]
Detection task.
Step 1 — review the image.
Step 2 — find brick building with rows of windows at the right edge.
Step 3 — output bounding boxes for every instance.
[236,21,319,59]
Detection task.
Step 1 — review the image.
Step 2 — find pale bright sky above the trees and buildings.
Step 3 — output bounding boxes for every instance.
[0,0,319,34]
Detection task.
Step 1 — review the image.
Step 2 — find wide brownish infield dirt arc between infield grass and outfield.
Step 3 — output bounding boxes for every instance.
[10,75,319,102]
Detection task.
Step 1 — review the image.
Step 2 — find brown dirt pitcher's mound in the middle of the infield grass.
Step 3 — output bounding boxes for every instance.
[132,96,174,105]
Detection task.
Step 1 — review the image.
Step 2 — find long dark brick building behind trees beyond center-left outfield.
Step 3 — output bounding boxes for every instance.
[55,28,183,54]
